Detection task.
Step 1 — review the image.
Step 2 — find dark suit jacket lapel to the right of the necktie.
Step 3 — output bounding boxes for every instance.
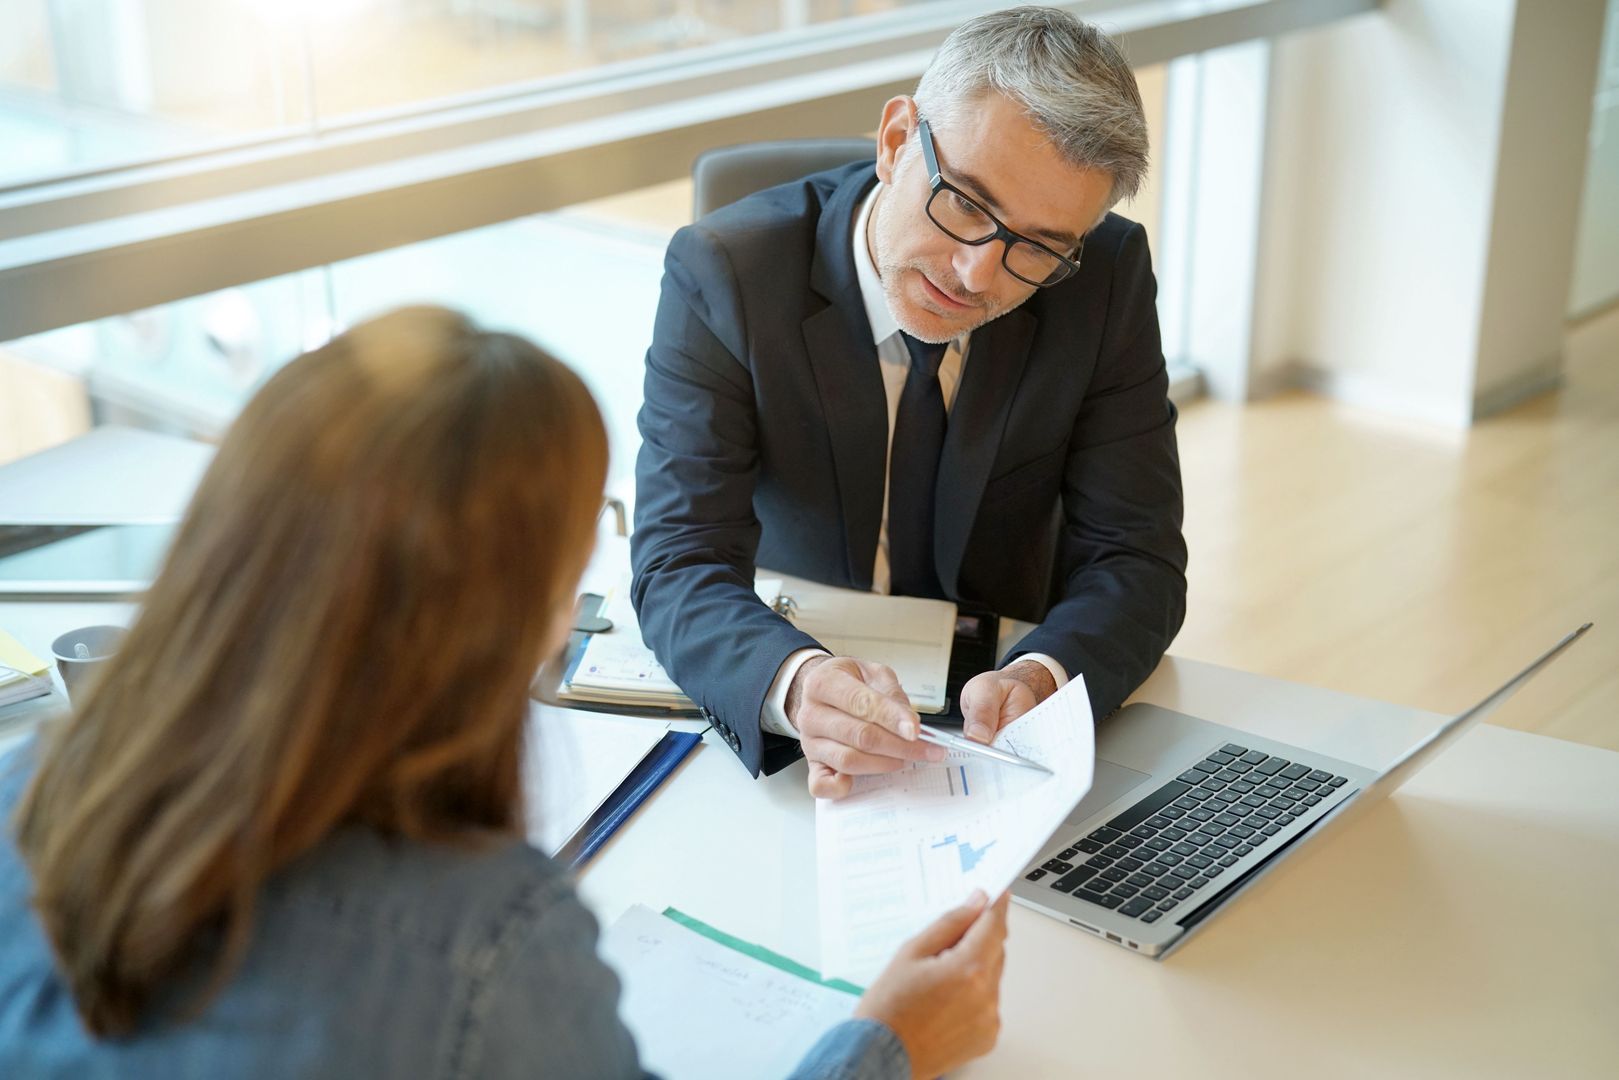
[933,308,1039,599]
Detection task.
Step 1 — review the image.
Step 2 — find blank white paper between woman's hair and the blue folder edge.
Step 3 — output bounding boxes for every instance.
[523,703,669,855]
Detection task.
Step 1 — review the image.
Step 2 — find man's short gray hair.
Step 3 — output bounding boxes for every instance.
[916,6,1148,206]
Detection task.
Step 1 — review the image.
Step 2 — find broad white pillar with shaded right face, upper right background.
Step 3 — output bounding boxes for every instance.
[1253,0,1603,426]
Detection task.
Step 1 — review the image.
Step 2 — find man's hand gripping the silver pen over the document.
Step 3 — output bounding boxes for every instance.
[787,656,945,798]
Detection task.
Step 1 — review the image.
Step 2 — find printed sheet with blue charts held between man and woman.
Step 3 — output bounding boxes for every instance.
[814,677,1096,984]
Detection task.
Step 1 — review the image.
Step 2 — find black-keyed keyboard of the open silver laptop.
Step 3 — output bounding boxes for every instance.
[1025,743,1347,923]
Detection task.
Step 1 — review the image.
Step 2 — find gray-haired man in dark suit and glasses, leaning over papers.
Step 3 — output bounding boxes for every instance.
[631,8,1187,797]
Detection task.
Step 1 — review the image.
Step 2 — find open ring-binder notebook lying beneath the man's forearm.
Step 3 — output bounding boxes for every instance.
[557,575,955,712]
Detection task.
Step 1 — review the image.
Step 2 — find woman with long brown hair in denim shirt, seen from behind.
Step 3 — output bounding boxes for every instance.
[0,308,1005,1077]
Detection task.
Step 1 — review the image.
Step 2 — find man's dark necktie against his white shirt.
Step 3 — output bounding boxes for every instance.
[889,332,945,597]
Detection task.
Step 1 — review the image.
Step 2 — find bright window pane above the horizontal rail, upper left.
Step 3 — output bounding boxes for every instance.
[0,0,997,183]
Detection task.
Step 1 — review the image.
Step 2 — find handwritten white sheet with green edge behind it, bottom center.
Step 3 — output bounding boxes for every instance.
[601,904,858,1080]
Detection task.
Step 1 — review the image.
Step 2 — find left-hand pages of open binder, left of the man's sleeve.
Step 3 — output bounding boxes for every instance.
[557,575,782,711]
